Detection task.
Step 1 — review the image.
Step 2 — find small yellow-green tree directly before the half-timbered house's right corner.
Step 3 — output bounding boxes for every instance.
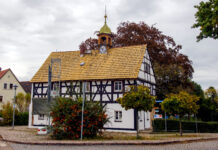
[116,85,156,138]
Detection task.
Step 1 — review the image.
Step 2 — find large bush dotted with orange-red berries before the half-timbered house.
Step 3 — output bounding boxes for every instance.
[51,98,108,139]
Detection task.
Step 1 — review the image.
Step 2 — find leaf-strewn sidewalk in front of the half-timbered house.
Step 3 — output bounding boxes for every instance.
[0,126,218,145]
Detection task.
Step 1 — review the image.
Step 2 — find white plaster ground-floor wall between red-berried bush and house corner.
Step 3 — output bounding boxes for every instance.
[104,104,134,129]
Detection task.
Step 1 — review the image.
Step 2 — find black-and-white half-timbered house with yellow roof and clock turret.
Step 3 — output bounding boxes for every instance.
[29,14,156,131]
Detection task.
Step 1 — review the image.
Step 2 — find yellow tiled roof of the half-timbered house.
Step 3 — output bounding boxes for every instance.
[31,45,146,82]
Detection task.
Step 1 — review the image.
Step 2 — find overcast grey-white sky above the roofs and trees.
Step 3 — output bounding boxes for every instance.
[0,0,218,89]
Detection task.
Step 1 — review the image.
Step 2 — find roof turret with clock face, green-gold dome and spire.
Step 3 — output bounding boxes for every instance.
[98,13,112,54]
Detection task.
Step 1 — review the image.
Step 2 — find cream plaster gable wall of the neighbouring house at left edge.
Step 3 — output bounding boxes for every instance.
[0,70,26,110]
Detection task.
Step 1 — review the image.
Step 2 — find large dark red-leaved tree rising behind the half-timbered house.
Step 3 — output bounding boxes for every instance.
[80,21,194,99]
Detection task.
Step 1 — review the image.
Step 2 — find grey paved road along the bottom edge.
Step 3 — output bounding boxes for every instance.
[10,141,218,150]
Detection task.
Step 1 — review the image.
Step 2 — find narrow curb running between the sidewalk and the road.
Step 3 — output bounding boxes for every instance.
[0,136,218,146]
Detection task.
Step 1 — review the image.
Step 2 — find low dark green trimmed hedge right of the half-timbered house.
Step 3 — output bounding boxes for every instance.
[152,119,218,133]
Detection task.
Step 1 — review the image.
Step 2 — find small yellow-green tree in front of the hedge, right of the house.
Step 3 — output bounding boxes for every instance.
[161,91,199,136]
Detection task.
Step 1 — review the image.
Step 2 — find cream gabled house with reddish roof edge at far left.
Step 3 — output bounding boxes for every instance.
[0,68,26,110]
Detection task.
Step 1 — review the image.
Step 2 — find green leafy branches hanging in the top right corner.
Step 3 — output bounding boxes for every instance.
[192,0,218,41]
